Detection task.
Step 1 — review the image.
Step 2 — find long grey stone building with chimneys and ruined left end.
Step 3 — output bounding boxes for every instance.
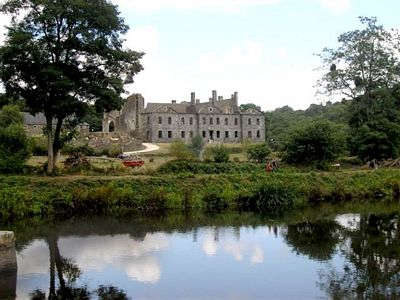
[103,91,265,143]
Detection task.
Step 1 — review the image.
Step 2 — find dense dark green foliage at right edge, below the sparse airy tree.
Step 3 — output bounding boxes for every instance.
[349,85,400,162]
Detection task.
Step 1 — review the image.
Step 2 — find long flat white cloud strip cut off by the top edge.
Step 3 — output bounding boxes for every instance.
[113,0,281,12]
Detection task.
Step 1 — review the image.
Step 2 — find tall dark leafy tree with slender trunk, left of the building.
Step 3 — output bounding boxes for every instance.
[0,0,144,173]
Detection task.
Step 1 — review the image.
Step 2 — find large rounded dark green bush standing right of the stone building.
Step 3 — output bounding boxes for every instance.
[284,120,346,167]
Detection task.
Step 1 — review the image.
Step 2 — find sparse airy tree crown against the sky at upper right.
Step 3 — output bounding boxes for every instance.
[319,17,400,99]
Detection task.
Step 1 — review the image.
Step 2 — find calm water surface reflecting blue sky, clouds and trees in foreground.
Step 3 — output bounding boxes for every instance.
[0,212,400,299]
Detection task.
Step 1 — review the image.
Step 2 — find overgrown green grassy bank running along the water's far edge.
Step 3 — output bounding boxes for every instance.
[0,169,400,222]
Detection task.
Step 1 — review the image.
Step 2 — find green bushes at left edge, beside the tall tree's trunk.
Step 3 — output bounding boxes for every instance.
[0,106,30,173]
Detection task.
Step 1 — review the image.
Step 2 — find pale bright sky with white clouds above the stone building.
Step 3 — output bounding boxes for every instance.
[0,0,400,110]
